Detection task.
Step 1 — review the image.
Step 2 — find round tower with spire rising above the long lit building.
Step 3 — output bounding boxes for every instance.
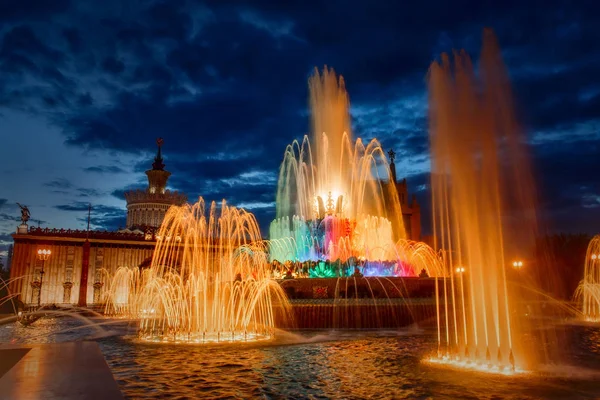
[122,138,187,233]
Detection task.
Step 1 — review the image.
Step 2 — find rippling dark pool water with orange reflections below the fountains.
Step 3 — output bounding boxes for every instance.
[0,318,600,399]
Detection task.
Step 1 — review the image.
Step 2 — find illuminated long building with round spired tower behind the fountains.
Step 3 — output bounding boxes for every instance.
[10,139,187,306]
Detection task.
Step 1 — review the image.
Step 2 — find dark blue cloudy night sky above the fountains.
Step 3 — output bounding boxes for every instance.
[0,0,600,260]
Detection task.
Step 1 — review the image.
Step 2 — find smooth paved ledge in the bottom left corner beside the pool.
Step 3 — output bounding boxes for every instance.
[0,342,123,400]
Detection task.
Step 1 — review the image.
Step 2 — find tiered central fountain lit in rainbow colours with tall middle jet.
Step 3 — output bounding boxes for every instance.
[269,67,435,277]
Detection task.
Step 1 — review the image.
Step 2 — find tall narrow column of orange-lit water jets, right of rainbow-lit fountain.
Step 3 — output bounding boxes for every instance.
[429,30,536,373]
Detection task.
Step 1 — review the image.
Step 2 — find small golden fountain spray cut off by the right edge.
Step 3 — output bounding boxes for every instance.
[575,235,600,322]
